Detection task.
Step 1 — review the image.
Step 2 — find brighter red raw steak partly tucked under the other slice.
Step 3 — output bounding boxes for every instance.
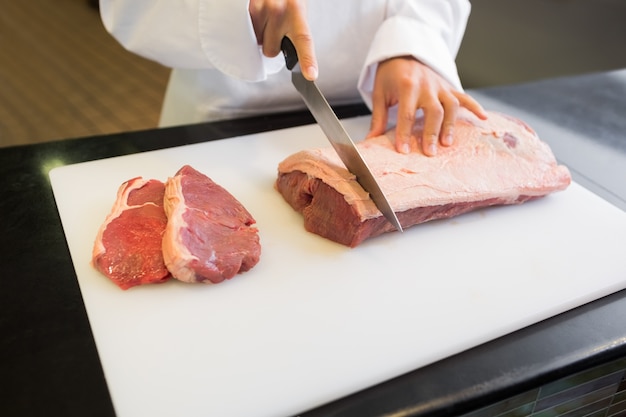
[92,177,170,290]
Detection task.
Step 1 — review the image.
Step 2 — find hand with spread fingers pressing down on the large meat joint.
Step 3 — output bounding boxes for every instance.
[367,57,487,156]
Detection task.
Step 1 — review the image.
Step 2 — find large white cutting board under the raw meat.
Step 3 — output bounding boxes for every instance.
[50,117,626,417]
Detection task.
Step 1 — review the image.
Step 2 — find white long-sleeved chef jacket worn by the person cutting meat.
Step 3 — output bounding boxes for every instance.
[100,0,470,126]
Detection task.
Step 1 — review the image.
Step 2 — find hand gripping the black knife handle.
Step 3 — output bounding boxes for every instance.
[248,0,318,81]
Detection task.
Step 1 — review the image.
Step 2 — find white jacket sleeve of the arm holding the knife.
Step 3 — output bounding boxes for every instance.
[100,0,284,81]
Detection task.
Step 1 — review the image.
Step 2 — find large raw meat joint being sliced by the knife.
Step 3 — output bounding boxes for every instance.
[276,112,571,247]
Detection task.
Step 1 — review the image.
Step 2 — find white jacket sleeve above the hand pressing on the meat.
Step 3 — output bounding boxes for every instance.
[359,0,471,108]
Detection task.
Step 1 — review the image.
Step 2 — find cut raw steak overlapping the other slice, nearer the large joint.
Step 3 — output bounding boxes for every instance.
[163,165,261,283]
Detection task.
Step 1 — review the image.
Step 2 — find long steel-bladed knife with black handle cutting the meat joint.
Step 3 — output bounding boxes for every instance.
[281,36,402,232]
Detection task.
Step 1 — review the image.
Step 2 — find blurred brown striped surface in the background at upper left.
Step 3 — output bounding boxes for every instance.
[0,0,170,147]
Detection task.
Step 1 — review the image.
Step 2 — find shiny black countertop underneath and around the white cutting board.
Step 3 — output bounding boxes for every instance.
[0,71,626,417]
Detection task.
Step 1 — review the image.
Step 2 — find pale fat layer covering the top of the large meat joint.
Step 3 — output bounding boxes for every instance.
[278,112,571,220]
